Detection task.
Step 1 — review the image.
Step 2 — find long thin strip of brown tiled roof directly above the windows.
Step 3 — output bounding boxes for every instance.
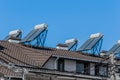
[28,47,106,62]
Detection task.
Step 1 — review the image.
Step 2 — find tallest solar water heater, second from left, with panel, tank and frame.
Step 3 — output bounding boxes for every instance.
[20,23,48,46]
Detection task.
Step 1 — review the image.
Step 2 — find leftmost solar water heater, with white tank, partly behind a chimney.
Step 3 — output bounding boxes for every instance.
[4,29,22,41]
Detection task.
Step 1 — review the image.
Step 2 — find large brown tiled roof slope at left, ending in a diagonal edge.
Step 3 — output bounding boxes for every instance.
[0,41,51,67]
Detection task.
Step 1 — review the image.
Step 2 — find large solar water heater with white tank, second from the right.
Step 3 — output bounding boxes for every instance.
[77,33,103,54]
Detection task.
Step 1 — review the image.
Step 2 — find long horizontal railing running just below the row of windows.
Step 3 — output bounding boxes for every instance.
[29,69,108,79]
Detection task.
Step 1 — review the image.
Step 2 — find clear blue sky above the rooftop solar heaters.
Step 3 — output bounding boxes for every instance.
[0,0,120,50]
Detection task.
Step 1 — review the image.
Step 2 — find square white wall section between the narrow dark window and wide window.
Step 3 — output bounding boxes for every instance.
[64,60,76,71]
